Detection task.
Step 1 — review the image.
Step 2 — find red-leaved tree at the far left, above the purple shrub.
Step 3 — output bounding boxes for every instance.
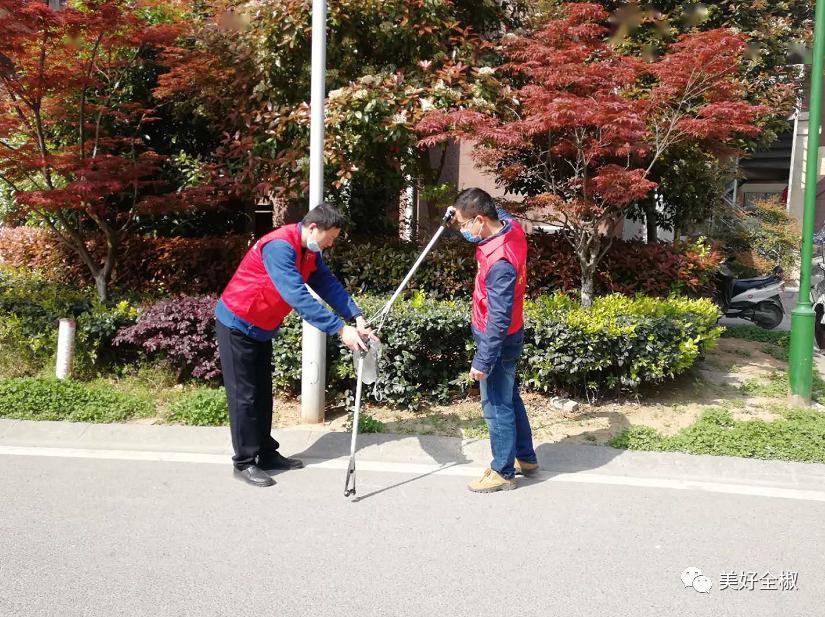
[0,0,183,300]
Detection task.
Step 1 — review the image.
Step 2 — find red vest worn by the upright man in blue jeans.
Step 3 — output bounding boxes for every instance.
[473,219,527,335]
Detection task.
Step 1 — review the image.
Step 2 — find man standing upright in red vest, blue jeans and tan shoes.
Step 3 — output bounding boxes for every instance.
[455,188,539,493]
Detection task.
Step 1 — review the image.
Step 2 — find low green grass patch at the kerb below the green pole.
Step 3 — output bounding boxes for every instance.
[610,408,825,463]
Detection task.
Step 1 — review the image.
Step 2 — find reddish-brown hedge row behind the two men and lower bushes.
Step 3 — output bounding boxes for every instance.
[0,227,720,298]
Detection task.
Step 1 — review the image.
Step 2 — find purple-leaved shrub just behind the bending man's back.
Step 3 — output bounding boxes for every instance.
[113,296,221,381]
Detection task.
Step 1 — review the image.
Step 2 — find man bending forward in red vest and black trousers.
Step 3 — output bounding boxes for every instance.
[215,204,371,486]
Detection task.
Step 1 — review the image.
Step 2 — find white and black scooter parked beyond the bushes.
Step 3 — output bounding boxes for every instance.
[714,263,785,330]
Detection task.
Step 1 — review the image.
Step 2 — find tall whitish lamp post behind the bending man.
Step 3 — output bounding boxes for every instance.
[301,0,327,423]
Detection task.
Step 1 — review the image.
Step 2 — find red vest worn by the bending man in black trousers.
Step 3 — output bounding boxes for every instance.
[221,224,316,330]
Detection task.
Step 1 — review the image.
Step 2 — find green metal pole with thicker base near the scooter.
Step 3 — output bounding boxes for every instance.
[789,2,825,405]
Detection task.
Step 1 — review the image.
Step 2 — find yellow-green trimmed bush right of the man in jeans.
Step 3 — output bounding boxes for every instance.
[521,294,721,394]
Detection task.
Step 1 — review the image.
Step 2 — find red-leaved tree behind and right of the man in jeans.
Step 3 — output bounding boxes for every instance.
[417,3,766,307]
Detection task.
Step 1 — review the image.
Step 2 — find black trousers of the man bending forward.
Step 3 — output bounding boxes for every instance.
[215,322,278,469]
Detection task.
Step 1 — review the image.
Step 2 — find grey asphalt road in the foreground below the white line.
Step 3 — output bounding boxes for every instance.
[0,454,825,617]
